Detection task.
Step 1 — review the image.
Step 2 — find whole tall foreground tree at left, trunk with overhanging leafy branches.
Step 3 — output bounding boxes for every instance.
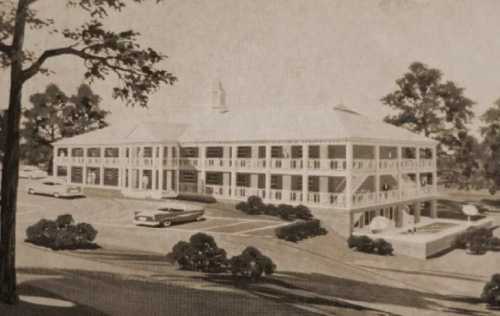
[0,0,176,303]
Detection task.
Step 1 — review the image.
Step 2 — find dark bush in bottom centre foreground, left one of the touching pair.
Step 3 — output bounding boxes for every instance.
[167,233,228,273]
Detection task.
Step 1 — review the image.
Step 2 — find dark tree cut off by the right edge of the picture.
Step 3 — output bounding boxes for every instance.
[481,99,500,194]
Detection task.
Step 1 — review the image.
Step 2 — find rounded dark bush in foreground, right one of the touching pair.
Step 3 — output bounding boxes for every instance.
[230,247,276,280]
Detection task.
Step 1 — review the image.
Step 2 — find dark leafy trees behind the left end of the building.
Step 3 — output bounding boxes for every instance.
[21,84,108,172]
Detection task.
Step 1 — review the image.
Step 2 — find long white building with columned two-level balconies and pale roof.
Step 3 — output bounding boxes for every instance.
[53,106,437,234]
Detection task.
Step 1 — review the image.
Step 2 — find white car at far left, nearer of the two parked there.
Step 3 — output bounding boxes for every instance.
[28,177,84,198]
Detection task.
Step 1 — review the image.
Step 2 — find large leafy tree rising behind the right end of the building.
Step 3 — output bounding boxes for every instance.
[382,62,479,188]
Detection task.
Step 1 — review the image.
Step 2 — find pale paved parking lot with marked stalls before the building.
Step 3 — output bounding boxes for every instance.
[18,180,286,237]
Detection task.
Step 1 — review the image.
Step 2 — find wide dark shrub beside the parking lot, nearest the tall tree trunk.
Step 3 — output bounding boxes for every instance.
[26,214,97,250]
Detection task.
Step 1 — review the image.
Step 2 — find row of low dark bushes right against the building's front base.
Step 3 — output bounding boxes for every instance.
[236,196,313,221]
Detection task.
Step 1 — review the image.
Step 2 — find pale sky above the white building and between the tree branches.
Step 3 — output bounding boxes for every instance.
[0,0,500,133]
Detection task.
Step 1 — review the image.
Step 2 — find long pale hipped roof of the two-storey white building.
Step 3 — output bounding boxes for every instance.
[52,106,436,145]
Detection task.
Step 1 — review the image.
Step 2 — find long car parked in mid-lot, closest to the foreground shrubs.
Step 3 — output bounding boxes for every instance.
[134,202,205,227]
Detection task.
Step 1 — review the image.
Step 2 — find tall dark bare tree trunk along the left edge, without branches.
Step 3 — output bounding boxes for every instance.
[0,0,29,304]
